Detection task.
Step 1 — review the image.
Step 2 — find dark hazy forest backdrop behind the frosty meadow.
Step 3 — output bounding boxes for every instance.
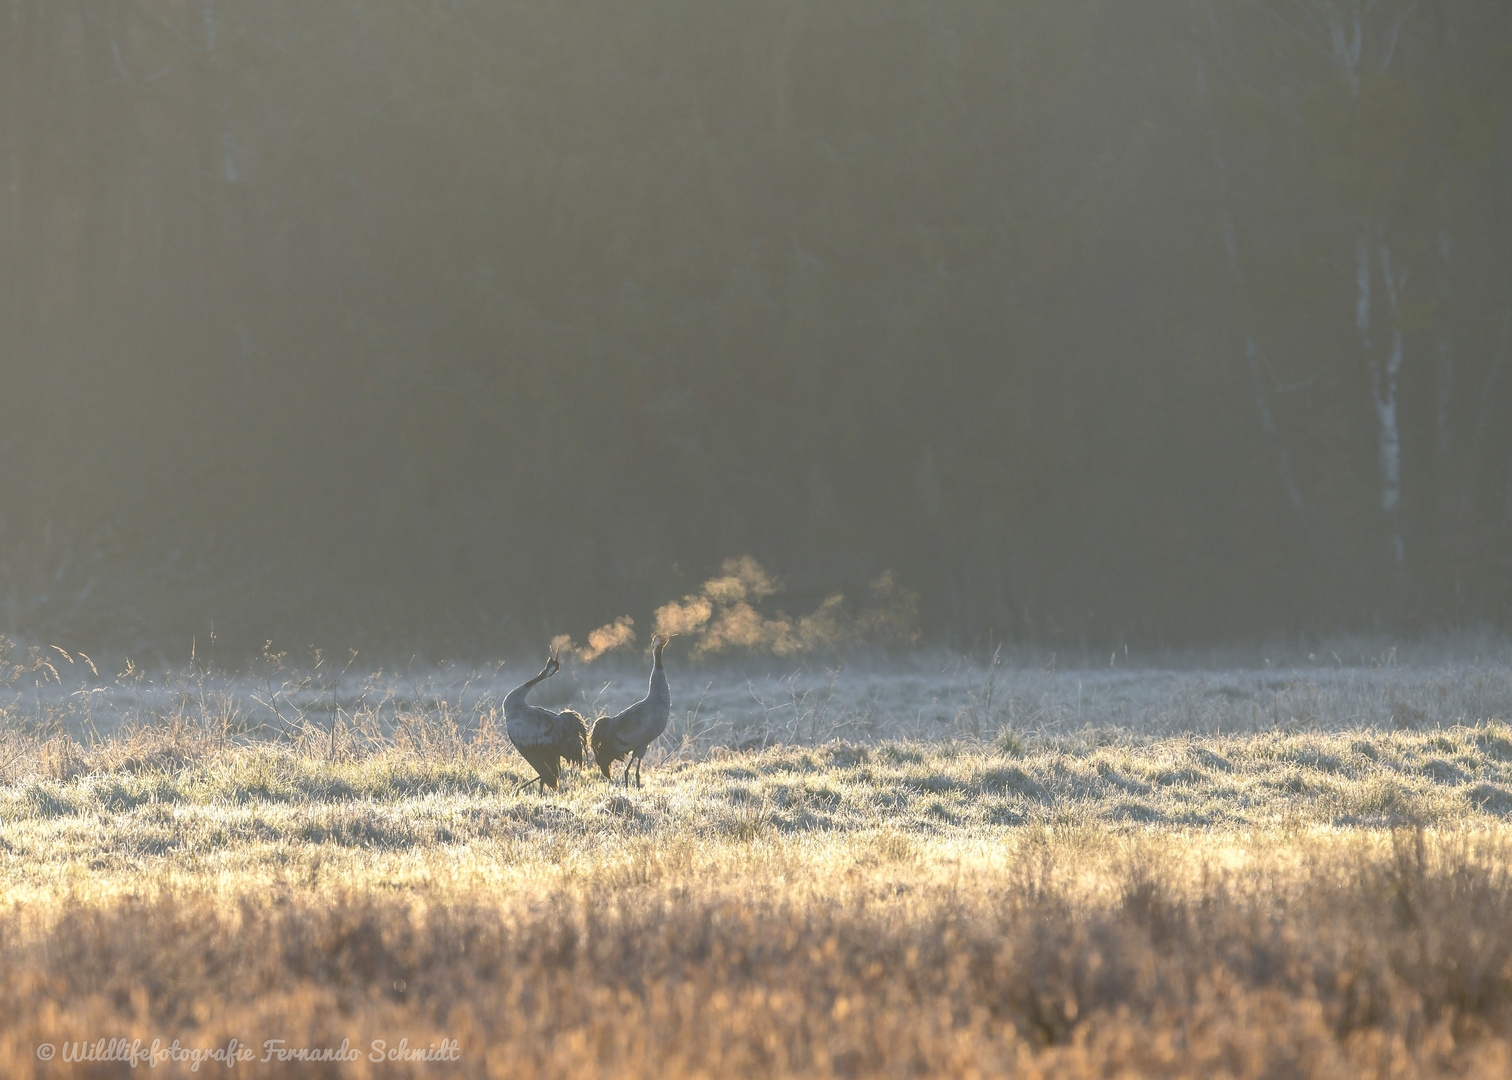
[0,0,1512,653]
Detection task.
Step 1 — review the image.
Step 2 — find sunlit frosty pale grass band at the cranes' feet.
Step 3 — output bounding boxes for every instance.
[0,722,1512,891]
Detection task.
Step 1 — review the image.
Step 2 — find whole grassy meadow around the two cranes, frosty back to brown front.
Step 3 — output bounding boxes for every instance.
[0,638,1512,1078]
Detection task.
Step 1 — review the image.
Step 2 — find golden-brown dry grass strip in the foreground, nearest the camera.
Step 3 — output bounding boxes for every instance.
[0,826,1512,1077]
